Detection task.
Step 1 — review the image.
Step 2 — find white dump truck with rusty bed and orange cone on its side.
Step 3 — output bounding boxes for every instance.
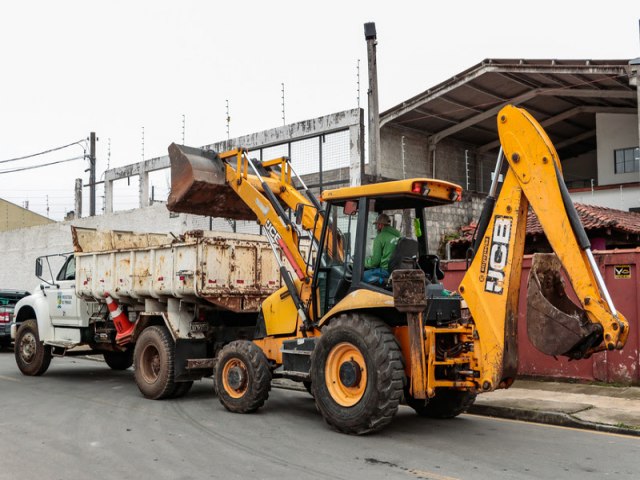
[12,227,280,399]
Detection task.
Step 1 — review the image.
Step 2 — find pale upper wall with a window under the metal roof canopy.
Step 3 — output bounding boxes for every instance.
[596,113,640,185]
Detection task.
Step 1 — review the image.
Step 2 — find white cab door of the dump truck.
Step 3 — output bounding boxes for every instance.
[47,255,82,327]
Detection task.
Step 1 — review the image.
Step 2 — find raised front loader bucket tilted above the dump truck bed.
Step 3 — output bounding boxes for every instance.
[167,143,256,220]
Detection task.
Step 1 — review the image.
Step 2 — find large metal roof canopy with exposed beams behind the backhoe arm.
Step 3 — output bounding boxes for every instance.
[380,59,637,158]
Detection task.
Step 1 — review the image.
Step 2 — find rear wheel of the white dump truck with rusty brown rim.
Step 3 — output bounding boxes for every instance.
[133,325,175,400]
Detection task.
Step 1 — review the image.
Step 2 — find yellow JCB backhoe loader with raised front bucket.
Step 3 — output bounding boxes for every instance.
[168,106,629,434]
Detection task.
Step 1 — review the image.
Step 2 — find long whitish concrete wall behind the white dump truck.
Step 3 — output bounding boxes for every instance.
[0,203,259,291]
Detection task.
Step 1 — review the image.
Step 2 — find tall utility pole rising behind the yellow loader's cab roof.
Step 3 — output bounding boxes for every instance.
[364,22,380,181]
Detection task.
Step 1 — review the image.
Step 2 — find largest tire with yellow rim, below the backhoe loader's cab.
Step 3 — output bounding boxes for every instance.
[311,313,404,435]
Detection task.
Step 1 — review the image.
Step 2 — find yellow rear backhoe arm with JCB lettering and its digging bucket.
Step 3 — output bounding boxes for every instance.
[460,106,628,390]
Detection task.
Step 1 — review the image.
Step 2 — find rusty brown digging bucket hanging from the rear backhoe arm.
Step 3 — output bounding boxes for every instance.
[527,253,602,359]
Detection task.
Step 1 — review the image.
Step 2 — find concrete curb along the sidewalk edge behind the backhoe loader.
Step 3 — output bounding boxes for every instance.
[467,404,640,437]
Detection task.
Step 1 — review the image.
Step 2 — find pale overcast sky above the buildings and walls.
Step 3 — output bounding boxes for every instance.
[0,0,640,220]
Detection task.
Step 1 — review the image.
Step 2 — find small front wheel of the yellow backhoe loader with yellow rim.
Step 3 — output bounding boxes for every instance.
[215,340,271,413]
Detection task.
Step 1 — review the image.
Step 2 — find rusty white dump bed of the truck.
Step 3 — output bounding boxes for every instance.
[72,227,280,312]
